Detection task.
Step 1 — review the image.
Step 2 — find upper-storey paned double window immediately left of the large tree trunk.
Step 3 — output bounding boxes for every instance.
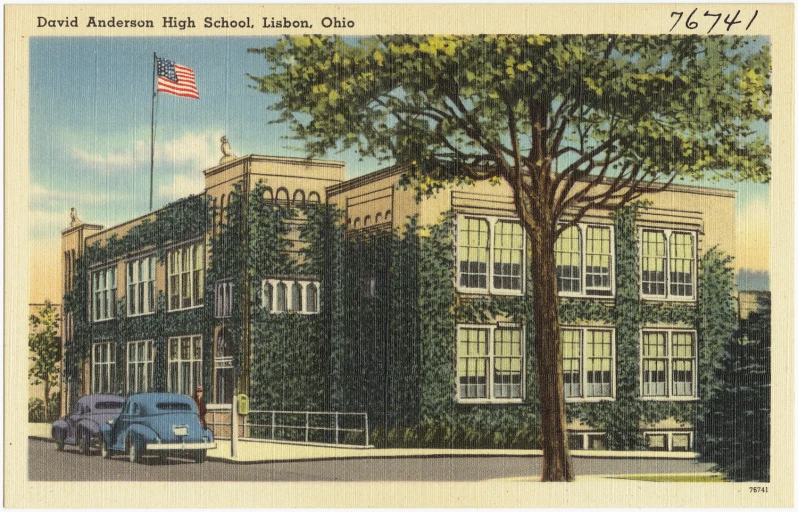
[457,216,525,295]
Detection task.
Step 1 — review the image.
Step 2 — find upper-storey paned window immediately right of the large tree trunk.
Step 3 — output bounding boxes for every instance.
[554,224,614,297]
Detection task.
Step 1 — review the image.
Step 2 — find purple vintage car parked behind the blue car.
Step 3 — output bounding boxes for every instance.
[51,395,125,455]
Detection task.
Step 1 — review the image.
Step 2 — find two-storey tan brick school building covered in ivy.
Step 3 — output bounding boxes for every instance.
[62,140,736,451]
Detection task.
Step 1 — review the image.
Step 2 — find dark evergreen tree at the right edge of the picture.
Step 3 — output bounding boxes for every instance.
[697,297,770,482]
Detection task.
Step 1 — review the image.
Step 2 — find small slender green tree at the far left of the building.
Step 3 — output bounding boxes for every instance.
[28,300,61,420]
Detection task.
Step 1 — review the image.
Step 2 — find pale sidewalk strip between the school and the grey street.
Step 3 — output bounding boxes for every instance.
[28,423,696,464]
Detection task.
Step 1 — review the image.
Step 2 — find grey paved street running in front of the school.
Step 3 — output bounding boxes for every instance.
[28,439,710,482]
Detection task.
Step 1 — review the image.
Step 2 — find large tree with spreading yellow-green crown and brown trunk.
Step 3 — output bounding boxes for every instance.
[250,35,770,481]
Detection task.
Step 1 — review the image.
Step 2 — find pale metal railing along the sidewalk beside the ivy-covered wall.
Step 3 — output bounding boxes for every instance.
[206,405,369,446]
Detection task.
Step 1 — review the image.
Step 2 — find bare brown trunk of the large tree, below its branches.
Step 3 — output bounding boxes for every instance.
[532,222,574,482]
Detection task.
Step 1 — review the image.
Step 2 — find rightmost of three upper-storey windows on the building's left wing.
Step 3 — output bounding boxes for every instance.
[169,244,205,311]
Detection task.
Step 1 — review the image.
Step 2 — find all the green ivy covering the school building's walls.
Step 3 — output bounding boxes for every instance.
[65,188,735,449]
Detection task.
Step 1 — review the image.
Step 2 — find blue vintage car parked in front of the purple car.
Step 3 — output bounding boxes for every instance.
[100,393,216,462]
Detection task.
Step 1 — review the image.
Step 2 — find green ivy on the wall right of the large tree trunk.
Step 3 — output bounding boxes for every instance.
[560,204,736,450]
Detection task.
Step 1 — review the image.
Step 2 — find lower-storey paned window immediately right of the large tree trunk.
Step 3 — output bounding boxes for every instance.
[560,327,615,400]
